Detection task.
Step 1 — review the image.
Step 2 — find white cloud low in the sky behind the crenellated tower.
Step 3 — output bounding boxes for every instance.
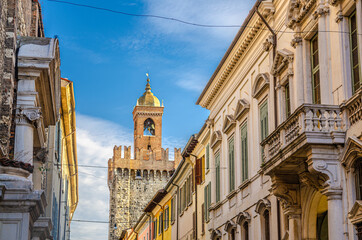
[71,114,185,240]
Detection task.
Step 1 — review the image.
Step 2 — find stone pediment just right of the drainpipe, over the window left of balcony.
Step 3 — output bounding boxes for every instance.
[271,48,294,75]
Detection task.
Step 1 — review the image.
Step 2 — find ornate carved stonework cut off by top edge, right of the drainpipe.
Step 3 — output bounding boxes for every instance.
[285,0,316,29]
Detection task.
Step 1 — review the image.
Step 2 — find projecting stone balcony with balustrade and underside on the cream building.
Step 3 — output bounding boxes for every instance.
[261,104,346,173]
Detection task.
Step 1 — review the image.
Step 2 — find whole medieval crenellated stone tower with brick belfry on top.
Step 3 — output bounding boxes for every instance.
[108,78,181,240]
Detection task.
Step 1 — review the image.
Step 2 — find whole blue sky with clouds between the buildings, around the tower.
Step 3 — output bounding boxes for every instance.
[40,0,254,239]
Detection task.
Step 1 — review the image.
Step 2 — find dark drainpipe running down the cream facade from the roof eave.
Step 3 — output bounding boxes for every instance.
[255,4,281,239]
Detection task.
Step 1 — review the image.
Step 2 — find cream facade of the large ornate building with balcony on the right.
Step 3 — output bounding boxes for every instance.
[197,0,362,240]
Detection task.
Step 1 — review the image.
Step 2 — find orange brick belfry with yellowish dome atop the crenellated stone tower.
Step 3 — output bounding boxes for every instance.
[133,75,163,160]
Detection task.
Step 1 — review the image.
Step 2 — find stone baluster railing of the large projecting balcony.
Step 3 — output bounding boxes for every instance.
[261,104,345,162]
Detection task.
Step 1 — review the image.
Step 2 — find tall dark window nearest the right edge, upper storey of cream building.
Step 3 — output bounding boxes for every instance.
[349,11,361,93]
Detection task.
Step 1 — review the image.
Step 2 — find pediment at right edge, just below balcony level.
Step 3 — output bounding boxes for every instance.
[341,136,362,170]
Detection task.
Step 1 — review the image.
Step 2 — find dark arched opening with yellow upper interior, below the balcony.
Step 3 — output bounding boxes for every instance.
[317,195,328,240]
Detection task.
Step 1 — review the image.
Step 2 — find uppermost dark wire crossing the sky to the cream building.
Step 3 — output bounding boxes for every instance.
[47,0,362,35]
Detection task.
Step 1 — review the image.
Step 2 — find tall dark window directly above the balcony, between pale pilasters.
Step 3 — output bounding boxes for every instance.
[311,34,321,104]
